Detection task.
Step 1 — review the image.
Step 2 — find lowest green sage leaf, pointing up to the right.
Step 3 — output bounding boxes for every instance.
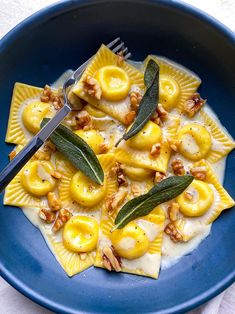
[113,175,194,230]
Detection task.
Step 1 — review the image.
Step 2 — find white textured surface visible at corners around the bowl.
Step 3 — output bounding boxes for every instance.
[0,0,235,314]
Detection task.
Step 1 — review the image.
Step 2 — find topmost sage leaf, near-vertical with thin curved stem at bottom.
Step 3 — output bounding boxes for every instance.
[115,59,159,147]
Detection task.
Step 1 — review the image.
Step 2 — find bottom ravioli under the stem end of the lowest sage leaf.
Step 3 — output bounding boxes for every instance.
[95,208,165,278]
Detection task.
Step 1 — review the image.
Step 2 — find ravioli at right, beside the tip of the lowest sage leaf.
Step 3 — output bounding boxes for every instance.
[171,160,235,241]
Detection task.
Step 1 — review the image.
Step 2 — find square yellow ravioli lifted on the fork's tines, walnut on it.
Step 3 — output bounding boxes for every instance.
[70,45,145,123]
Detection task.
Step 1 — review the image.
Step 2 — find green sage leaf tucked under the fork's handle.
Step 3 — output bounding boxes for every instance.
[41,118,104,184]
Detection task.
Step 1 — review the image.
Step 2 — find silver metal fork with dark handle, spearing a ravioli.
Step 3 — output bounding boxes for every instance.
[0,37,131,192]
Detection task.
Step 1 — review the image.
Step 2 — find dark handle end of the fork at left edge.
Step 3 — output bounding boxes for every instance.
[0,137,43,193]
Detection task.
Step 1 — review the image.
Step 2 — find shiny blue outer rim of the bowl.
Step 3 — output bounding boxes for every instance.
[0,0,235,314]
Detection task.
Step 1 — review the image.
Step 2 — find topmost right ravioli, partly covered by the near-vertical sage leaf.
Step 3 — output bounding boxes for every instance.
[144,55,201,111]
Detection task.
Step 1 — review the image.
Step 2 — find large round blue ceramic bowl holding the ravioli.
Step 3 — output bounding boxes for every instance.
[0,0,235,313]
